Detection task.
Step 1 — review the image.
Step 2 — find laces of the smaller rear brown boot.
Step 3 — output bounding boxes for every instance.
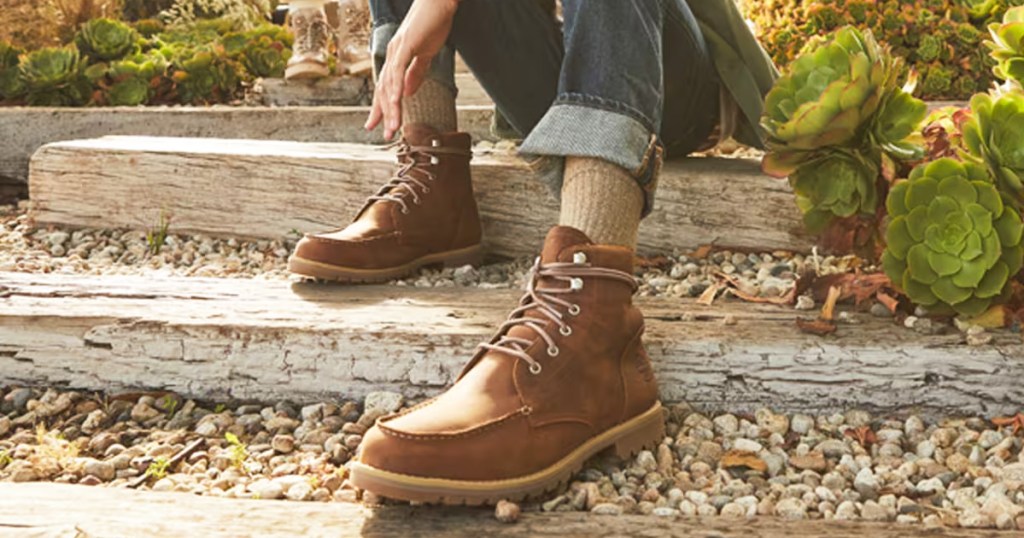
[367,139,470,214]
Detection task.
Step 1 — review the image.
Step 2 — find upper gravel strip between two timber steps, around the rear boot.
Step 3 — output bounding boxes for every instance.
[0,200,852,301]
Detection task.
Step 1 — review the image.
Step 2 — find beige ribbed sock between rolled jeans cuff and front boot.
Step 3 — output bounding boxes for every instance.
[559,157,644,249]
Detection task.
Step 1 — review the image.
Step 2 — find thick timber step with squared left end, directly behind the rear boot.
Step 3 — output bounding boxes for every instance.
[29,136,811,256]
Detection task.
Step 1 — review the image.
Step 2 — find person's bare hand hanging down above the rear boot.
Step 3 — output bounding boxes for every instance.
[366,0,459,140]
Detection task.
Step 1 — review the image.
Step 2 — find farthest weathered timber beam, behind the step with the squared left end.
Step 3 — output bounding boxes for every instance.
[0,107,494,183]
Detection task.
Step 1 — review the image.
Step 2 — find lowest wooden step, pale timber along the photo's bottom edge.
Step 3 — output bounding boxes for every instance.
[0,484,995,538]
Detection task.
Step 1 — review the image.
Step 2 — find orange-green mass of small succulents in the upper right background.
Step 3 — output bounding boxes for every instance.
[744,0,999,99]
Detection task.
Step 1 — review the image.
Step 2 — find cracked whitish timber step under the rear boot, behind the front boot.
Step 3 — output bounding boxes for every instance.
[0,273,1024,417]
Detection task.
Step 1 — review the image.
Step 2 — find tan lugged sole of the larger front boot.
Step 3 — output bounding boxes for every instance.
[349,403,665,505]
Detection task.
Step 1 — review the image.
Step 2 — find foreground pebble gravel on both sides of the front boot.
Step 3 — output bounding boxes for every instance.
[0,386,1024,530]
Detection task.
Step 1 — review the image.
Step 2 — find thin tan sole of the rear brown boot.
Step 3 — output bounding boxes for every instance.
[288,245,483,284]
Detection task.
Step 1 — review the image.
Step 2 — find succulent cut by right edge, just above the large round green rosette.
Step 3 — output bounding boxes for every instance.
[962,91,1024,210]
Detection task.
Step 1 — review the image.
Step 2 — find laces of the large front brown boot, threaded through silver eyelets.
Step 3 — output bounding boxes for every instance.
[478,252,639,375]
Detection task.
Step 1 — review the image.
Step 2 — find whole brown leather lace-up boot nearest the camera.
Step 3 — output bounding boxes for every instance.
[350,226,665,504]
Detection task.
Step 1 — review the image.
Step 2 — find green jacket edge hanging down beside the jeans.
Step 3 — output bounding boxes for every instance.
[687,0,778,148]
